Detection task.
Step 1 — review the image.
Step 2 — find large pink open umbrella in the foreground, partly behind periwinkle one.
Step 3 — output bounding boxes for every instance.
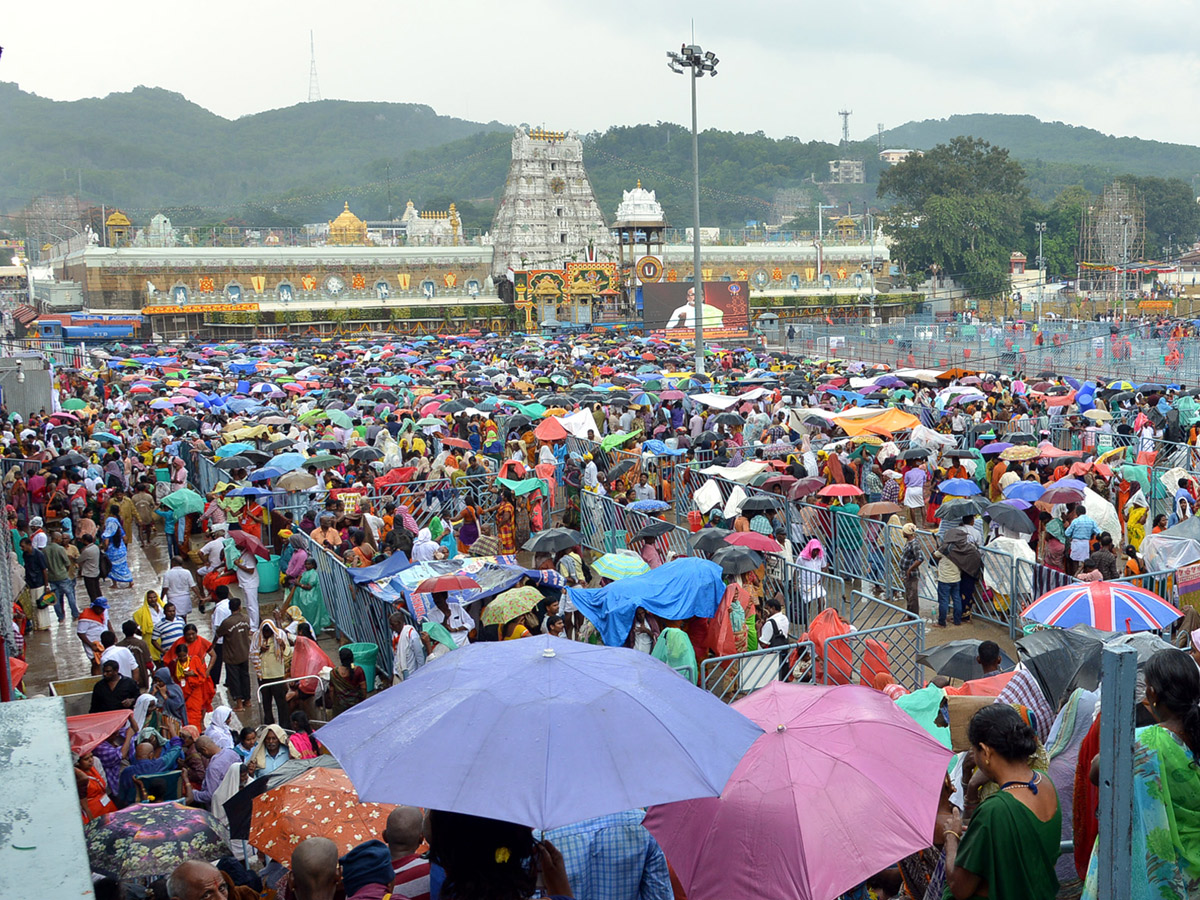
[646,682,953,900]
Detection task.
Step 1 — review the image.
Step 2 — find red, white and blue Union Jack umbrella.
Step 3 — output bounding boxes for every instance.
[1021,581,1183,631]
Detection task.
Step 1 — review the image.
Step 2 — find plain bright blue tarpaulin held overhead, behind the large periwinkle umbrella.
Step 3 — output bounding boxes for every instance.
[568,557,725,647]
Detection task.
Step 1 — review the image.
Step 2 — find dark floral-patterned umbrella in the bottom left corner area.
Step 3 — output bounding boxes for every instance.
[84,803,229,881]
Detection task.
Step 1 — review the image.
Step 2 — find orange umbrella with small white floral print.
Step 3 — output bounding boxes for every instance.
[250,768,395,865]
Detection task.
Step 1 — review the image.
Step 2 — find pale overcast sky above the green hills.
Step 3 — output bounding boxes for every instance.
[9,0,1200,144]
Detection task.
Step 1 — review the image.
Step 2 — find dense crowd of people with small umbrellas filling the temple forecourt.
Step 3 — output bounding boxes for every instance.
[7,336,1200,900]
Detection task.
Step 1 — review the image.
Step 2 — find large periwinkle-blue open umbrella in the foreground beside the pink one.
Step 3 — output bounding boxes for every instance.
[320,635,762,829]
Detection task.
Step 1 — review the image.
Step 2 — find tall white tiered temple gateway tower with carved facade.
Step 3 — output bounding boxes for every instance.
[492,128,617,277]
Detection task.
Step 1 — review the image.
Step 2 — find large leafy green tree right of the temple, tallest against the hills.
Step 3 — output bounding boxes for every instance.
[878,137,1028,296]
